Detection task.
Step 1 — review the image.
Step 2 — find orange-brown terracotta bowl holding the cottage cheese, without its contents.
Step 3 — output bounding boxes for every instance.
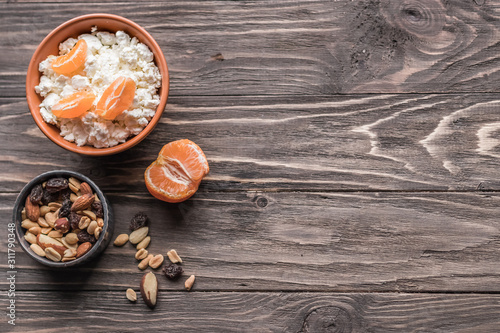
[26,14,169,156]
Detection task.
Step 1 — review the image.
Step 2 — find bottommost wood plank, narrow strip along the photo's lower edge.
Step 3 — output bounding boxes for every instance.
[0,292,500,333]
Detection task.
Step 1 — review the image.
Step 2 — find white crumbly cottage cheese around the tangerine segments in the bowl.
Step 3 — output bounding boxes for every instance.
[35,29,161,148]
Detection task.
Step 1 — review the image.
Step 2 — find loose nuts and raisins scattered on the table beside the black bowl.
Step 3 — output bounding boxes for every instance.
[113,212,195,308]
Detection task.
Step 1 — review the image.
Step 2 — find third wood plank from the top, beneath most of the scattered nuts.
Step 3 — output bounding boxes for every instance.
[0,192,500,292]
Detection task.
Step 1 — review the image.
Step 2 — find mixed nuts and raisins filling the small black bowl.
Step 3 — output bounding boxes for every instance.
[21,177,104,262]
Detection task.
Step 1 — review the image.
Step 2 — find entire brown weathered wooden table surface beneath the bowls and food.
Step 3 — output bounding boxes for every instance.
[0,0,500,333]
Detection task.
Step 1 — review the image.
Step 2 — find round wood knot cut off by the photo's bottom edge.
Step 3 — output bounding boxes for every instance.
[300,306,355,333]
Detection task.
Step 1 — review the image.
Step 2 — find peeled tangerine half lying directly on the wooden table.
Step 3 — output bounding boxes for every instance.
[144,139,209,202]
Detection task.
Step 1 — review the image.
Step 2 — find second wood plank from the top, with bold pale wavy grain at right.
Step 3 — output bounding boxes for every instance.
[0,94,500,191]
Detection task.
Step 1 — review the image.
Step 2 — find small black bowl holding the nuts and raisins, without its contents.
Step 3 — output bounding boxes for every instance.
[13,170,114,268]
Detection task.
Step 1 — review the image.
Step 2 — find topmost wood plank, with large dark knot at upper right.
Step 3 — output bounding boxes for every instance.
[0,0,500,96]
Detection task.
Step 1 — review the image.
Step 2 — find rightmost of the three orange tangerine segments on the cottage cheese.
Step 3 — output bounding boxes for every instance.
[96,76,135,120]
